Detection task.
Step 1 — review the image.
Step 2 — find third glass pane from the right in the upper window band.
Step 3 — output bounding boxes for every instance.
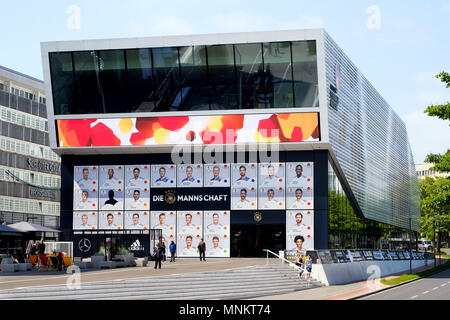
[235,43,266,109]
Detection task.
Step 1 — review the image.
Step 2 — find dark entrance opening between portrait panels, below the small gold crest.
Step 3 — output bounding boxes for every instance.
[231,224,286,257]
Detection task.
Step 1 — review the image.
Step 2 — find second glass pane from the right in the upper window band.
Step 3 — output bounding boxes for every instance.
[264,42,294,108]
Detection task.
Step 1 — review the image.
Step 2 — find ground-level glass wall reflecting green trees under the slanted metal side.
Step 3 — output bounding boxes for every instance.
[328,163,410,249]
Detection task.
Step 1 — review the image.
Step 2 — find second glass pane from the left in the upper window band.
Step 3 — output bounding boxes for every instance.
[73,51,103,113]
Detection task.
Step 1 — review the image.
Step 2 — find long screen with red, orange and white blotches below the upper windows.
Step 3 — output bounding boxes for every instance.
[57,112,320,147]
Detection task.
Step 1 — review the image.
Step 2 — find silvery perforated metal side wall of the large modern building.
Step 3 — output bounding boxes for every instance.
[324,32,420,231]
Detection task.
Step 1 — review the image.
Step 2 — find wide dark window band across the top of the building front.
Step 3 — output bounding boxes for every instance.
[49,41,318,115]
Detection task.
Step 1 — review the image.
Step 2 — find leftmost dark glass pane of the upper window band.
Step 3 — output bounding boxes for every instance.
[49,52,75,114]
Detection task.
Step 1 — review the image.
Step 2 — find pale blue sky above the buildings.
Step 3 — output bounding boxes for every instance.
[0,0,450,163]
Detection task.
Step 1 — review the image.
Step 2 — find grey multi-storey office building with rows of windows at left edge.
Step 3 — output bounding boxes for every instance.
[0,66,60,228]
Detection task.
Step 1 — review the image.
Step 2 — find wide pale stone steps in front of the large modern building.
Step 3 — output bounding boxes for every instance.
[0,264,322,300]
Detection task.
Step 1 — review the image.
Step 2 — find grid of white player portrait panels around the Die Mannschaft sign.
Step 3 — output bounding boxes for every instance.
[73,162,314,251]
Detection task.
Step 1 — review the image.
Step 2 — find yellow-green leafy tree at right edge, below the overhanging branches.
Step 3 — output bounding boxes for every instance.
[420,177,450,239]
